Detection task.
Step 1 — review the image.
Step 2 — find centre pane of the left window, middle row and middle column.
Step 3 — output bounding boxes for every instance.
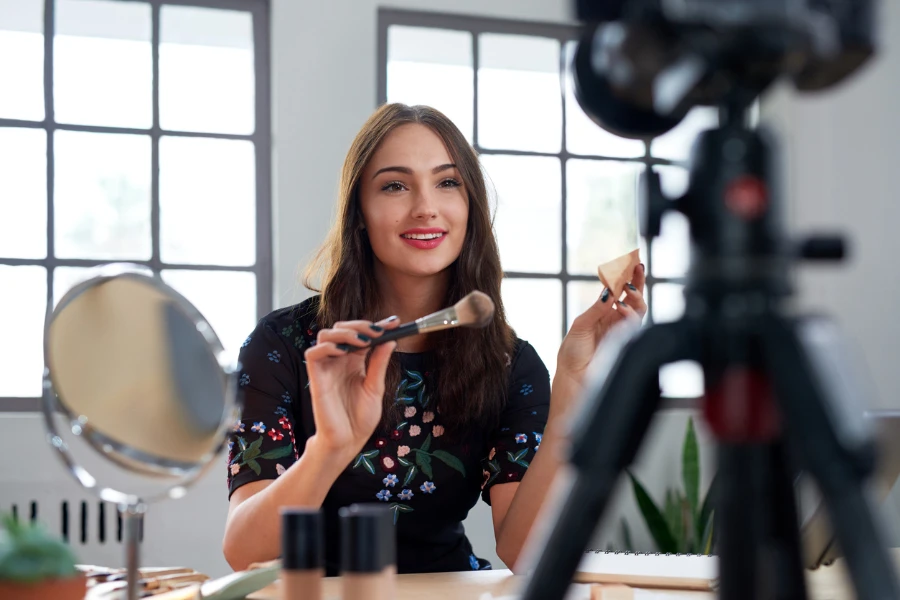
[54,131,151,260]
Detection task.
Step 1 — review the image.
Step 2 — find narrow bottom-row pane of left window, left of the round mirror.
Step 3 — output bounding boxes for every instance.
[0,265,47,398]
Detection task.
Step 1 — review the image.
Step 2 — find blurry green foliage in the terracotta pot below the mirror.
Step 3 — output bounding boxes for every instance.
[0,515,78,583]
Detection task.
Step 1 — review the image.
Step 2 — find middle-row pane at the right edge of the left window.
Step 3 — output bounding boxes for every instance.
[159,137,256,265]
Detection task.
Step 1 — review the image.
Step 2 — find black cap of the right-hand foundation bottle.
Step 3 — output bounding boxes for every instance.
[338,504,397,573]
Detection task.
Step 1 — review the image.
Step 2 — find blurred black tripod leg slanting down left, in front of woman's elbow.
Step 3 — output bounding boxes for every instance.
[522,321,696,600]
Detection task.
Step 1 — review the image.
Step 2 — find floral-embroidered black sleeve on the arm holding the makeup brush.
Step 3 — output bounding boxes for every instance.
[228,319,299,498]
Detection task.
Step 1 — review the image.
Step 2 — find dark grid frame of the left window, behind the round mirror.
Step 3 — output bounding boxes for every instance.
[0,0,274,413]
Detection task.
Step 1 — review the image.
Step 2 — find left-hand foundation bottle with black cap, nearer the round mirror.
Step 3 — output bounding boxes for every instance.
[280,508,325,600]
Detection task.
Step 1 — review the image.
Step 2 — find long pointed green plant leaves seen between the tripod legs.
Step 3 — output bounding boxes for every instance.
[622,418,716,554]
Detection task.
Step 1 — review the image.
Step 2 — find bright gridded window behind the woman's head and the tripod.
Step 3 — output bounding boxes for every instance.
[377,9,718,398]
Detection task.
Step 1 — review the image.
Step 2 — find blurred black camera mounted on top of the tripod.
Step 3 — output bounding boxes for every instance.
[573,0,875,139]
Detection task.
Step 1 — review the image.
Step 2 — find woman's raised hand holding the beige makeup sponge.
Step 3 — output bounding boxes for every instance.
[554,264,647,396]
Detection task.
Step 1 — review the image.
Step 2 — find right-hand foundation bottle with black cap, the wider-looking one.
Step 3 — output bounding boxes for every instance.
[338,504,397,600]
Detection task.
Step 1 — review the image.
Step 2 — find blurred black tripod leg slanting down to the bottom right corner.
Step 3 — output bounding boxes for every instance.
[760,317,900,599]
